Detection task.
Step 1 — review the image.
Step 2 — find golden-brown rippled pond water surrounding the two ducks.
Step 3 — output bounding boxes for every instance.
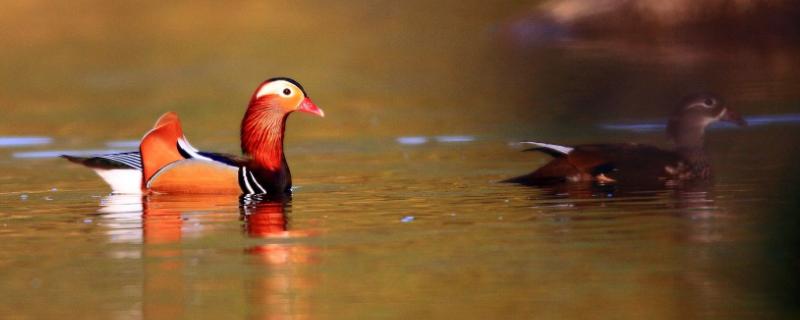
[0,1,800,319]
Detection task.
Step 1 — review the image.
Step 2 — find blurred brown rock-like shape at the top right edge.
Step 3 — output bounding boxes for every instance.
[500,0,800,44]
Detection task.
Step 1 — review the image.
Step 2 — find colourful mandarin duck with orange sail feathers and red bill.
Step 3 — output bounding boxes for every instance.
[63,78,325,195]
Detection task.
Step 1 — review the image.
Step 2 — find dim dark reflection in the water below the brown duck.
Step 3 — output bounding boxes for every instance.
[520,183,741,316]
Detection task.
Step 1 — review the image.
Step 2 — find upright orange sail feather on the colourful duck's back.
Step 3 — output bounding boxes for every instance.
[139,112,183,185]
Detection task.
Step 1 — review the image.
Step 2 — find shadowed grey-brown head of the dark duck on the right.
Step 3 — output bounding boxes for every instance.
[667,93,747,149]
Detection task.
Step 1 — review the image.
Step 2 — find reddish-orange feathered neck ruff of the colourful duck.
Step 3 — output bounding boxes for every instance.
[241,107,287,172]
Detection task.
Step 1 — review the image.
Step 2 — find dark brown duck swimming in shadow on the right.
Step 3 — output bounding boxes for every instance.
[503,94,747,185]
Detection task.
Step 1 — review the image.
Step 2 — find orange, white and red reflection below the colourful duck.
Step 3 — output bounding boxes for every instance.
[98,195,315,319]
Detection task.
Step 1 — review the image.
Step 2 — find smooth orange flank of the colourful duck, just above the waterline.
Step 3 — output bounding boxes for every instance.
[145,159,241,194]
